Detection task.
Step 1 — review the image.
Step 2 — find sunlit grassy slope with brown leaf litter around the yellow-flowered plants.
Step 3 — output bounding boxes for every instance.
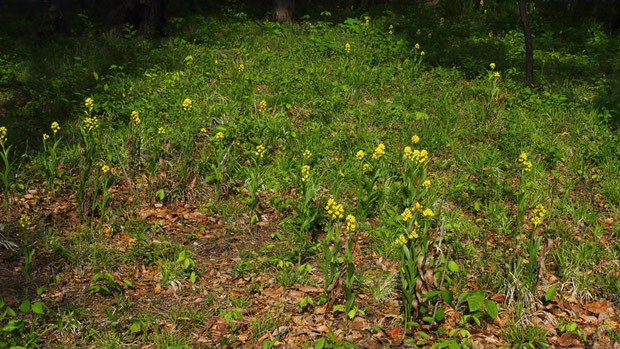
[2,6,620,346]
